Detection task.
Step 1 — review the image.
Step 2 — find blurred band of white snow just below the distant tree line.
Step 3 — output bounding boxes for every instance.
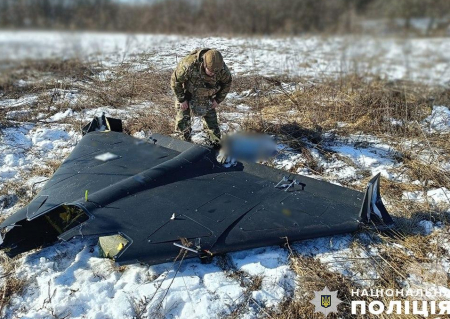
[0,31,450,84]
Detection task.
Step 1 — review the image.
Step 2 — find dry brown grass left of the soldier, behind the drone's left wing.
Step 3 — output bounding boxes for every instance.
[0,59,174,133]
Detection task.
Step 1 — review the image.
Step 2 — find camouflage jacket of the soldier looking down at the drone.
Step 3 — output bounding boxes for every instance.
[170,49,232,106]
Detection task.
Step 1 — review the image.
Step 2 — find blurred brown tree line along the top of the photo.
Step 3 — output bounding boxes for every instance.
[0,0,450,35]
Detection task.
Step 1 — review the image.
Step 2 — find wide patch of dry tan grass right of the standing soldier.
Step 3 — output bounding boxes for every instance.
[246,75,450,137]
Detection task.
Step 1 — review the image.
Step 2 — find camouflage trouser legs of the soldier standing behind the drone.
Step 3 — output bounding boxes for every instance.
[175,102,221,144]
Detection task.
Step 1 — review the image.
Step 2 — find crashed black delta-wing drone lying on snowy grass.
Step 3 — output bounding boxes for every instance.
[0,117,392,264]
